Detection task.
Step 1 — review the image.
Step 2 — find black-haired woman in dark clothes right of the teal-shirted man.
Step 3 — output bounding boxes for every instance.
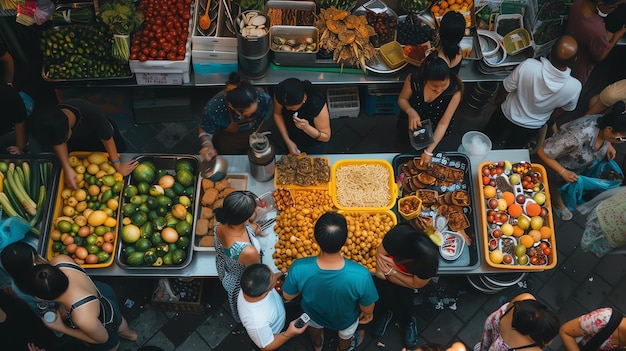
[371,224,439,350]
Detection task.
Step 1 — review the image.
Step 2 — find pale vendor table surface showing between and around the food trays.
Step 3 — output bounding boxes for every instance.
[77,149,530,277]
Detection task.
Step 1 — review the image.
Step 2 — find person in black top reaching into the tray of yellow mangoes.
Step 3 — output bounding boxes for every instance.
[28,99,139,189]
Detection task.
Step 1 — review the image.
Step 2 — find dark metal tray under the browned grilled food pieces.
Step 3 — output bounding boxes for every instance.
[392,152,481,272]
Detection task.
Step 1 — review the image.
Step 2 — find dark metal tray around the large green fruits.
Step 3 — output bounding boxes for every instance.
[115,154,200,270]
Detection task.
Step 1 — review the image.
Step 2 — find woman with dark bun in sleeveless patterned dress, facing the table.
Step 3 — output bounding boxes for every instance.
[213,191,262,322]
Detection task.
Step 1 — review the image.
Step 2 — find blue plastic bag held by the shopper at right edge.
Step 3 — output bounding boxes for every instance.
[559,159,624,211]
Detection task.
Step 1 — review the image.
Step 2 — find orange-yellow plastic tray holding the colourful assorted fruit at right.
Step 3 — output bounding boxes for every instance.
[477,162,557,271]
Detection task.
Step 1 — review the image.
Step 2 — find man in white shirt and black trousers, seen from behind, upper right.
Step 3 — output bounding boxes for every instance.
[484,35,582,149]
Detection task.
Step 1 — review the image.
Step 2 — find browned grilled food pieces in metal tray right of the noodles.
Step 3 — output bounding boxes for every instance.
[394,153,475,250]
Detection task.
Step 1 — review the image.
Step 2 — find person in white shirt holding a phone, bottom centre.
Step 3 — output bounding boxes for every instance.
[237,263,308,351]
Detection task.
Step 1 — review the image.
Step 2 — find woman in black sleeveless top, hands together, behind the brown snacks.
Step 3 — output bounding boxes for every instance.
[274,78,331,155]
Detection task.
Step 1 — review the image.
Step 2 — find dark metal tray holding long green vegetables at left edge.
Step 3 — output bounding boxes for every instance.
[0,154,61,254]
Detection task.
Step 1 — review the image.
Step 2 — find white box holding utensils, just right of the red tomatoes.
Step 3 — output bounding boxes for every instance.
[190,0,239,53]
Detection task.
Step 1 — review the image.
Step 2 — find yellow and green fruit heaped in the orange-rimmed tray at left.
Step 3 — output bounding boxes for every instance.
[47,152,124,268]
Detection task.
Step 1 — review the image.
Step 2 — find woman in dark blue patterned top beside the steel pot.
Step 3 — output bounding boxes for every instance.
[198,72,273,160]
